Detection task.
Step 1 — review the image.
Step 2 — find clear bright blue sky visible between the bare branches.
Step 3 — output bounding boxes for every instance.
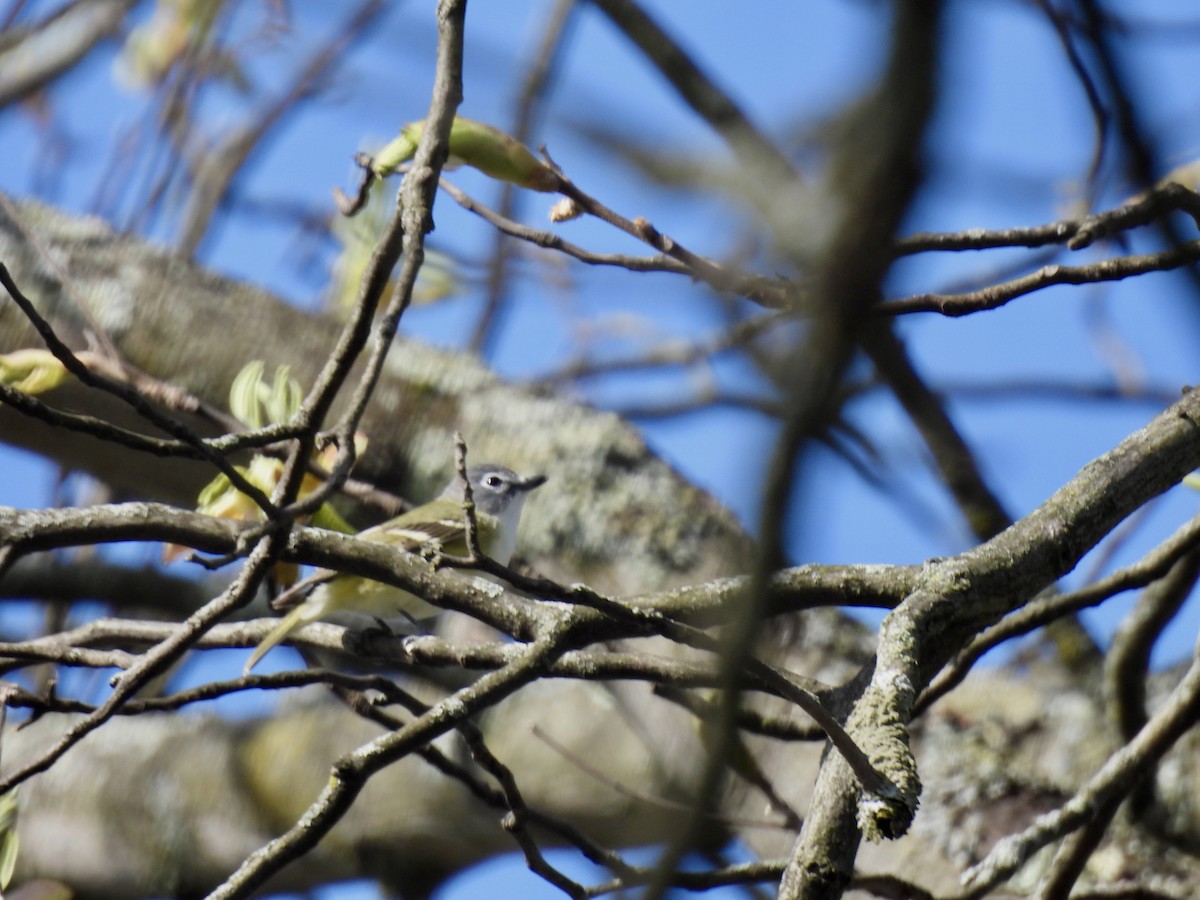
[0,0,1200,900]
